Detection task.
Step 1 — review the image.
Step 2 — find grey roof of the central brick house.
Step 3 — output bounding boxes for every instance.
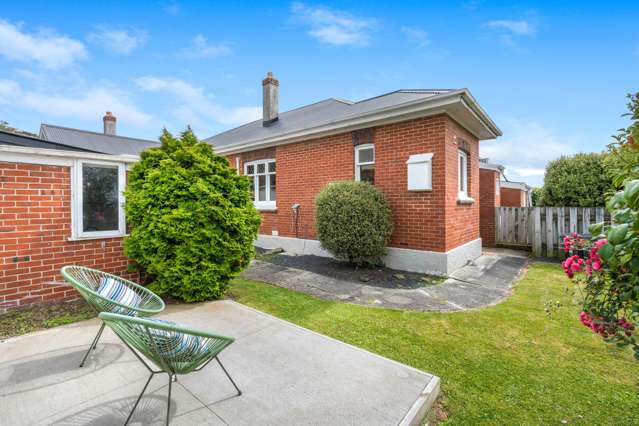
[204,89,453,147]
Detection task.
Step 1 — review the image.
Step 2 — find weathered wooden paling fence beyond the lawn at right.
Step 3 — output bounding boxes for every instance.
[495,207,609,257]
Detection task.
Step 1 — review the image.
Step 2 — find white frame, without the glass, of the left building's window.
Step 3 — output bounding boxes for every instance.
[71,160,126,239]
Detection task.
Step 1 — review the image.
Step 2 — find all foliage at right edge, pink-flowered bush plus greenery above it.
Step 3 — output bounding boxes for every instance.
[563,94,639,360]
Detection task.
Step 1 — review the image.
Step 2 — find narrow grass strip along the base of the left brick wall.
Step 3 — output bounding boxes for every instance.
[0,300,96,340]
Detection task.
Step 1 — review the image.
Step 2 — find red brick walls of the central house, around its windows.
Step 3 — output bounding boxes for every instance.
[228,115,479,252]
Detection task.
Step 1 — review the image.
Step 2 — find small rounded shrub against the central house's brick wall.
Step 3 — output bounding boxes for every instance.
[315,182,393,265]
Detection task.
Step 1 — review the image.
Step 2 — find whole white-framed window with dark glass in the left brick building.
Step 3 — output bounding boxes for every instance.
[71,160,126,239]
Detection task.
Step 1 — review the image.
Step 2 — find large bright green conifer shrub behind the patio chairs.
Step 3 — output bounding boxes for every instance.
[124,129,260,302]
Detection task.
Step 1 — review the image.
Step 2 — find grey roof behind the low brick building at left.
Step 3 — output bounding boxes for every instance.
[40,123,160,155]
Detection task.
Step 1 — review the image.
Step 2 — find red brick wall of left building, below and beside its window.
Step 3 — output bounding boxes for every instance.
[0,162,137,312]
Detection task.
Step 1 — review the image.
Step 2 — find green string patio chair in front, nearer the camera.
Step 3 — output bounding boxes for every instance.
[100,312,242,426]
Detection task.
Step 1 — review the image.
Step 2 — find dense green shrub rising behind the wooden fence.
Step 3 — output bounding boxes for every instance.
[540,153,612,207]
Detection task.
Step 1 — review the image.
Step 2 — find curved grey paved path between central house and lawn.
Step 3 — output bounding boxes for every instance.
[242,250,528,311]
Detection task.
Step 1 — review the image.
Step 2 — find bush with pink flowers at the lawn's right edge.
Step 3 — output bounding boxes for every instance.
[562,179,639,359]
